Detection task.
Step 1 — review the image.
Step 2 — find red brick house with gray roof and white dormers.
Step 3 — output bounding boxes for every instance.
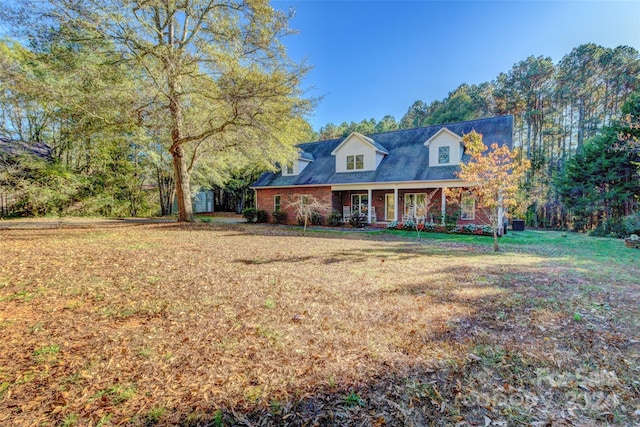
[252,116,513,224]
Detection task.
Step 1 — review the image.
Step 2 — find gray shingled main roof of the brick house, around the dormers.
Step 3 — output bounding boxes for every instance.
[253,116,513,187]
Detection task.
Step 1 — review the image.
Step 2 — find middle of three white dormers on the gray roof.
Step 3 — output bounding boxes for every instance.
[331,132,389,172]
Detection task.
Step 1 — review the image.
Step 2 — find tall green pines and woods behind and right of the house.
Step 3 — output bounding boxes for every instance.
[317,43,640,234]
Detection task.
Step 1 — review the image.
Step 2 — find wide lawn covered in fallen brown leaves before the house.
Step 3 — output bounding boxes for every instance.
[0,224,640,426]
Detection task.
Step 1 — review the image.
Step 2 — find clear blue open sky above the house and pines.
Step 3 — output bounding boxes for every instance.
[272,0,640,130]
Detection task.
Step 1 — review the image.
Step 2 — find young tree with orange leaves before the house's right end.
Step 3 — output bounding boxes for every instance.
[456,131,530,252]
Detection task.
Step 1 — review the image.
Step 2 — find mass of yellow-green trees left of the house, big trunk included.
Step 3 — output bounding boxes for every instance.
[0,0,314,221]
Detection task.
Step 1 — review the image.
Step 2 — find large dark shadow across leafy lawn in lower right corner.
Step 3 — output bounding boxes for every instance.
[156,266,640,426]
